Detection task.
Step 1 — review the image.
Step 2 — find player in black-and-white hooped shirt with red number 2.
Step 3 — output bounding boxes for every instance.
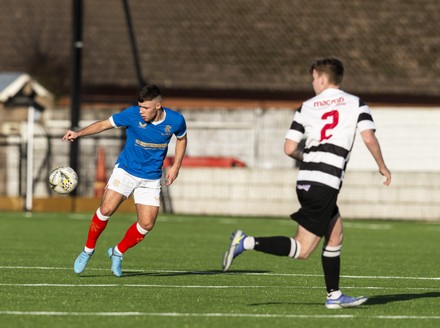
[223,58,391,309]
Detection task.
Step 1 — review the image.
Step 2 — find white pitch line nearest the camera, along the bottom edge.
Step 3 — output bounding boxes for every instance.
[0,311,440,320]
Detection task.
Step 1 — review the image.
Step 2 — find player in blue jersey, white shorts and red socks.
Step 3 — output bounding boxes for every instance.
[63,84,187,277]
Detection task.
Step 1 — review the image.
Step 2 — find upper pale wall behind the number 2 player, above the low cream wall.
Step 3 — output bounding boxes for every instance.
[175,107,440,172]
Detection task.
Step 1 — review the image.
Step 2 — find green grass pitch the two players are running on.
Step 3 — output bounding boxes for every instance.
[0,212,440,328]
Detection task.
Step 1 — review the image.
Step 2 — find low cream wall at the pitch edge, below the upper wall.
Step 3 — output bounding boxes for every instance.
[170,168,440,220]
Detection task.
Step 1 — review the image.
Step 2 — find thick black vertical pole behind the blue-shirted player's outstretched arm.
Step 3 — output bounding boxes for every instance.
[70,0,83,196]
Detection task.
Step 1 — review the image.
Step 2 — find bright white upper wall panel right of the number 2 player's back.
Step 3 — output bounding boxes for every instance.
[349,107,440,172]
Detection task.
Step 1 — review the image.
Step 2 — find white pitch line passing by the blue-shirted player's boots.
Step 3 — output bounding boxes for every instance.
[0,266,440,280]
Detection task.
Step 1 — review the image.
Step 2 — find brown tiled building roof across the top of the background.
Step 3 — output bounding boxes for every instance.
[0,0,440,99]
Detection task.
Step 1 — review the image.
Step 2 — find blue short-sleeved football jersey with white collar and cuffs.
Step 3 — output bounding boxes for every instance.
[110,106,186,180]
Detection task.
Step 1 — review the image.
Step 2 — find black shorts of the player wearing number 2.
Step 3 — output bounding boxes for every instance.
[290,183,339,237]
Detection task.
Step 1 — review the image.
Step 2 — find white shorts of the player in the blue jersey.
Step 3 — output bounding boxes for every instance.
[106,165,160,207]
